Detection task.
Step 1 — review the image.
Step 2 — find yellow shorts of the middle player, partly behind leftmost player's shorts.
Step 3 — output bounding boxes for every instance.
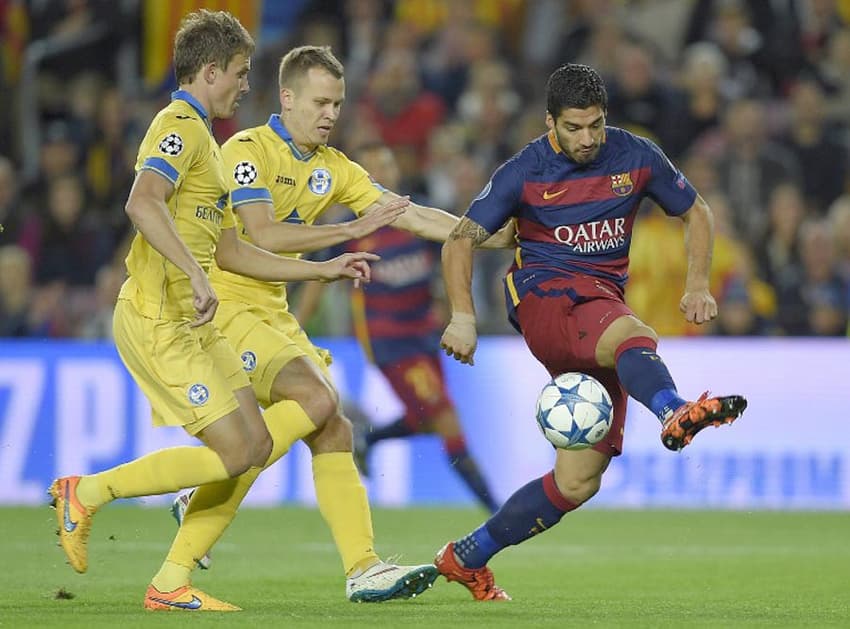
[214,300,332,408]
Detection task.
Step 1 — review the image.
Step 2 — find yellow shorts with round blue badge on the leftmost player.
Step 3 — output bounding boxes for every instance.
[113,299,249,435]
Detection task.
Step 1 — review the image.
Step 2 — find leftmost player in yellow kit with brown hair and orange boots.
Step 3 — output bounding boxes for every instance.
[44,10,374,611]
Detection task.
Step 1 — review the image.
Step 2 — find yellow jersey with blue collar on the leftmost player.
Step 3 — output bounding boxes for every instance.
[119,90,235,320]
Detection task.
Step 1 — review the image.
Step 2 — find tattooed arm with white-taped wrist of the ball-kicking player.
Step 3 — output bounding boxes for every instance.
[440,217,490,365]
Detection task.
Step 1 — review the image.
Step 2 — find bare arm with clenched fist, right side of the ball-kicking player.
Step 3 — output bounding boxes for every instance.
[679,195,717,323]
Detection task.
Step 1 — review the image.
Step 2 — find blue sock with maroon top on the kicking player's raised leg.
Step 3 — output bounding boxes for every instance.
[617,338,685,422]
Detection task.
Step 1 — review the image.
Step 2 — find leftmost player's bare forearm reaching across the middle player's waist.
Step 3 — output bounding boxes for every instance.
[215,228,379,282]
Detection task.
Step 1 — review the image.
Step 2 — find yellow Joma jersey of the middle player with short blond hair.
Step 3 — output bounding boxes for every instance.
[210,114,384,310]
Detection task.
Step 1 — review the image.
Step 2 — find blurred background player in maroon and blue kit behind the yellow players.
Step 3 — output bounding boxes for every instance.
[299,143,499,513]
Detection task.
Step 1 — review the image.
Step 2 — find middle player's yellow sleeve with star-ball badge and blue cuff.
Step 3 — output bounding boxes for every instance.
[221,135,272,210]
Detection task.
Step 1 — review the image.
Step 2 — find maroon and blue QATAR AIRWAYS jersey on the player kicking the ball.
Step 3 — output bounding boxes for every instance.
[466,127,697,325]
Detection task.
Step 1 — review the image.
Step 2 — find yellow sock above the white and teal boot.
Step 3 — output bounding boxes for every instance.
[313,452,379,574]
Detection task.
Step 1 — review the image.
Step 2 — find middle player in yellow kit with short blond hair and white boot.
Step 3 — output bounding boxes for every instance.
[169,46,512,601]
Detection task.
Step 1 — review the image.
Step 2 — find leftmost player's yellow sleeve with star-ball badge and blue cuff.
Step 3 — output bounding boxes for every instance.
[136,114,209,188]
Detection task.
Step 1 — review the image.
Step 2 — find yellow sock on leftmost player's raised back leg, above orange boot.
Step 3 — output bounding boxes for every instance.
[77,446,229,508]
